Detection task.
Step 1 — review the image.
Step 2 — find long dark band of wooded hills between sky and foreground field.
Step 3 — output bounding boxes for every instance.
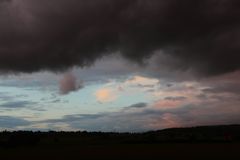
[0,125,240,148]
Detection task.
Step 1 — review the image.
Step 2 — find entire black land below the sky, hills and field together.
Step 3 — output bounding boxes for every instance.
[0,125,240,159]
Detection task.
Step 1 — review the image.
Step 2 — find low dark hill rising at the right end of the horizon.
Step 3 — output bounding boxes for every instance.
[143,125,240,142]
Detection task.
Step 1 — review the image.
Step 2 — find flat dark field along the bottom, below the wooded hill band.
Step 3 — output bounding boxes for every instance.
[0,143,240,160]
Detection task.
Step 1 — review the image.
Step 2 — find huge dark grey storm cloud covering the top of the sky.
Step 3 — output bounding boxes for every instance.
[0,0,240,74]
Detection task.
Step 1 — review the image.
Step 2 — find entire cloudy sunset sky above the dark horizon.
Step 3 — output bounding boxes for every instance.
[0,0,240,132]
